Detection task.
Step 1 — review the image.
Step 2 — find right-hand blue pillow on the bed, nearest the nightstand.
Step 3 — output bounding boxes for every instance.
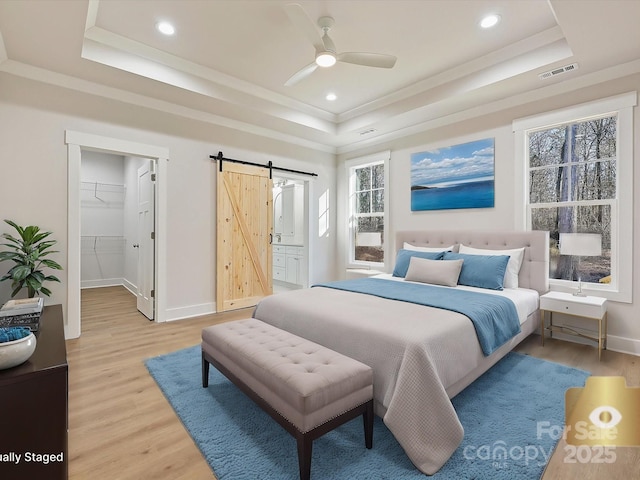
[444,252,509,290]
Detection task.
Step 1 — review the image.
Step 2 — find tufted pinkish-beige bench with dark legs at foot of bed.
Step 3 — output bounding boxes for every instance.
[202,318,373,480]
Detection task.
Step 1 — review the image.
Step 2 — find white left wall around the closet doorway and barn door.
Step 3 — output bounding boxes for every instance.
[0,73,336,332]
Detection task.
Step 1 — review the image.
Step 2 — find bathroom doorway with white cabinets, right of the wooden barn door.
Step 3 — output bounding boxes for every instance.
[272,172,309,293]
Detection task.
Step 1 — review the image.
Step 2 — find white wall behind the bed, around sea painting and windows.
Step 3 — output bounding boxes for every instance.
[338,75,640,355]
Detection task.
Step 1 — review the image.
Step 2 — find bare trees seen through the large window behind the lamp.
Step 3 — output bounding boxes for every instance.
[528,115,617,283]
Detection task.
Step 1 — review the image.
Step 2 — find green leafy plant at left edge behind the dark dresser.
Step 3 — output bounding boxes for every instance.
[0,220,62,298]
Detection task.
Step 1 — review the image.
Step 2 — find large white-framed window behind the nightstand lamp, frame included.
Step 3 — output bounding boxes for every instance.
[514,93,636,301]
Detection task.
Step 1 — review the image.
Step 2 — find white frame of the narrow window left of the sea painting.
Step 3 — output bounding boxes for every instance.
[344,150,391,269]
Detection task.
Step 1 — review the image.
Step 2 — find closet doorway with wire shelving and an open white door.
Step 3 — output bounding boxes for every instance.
[80,151,155,320]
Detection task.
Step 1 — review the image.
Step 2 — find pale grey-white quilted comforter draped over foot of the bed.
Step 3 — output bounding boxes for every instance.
[254,287,537,474]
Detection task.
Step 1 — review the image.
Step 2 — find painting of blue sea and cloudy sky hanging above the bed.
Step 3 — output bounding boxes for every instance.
[411,138,495,211]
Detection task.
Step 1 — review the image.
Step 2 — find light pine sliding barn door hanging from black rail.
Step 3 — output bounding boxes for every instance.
[216,162,273,312]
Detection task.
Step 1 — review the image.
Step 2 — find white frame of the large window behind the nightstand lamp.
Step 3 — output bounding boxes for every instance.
[512,92,638,303]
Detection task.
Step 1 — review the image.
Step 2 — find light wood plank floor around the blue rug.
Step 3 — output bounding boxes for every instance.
[67,287,640,480]
